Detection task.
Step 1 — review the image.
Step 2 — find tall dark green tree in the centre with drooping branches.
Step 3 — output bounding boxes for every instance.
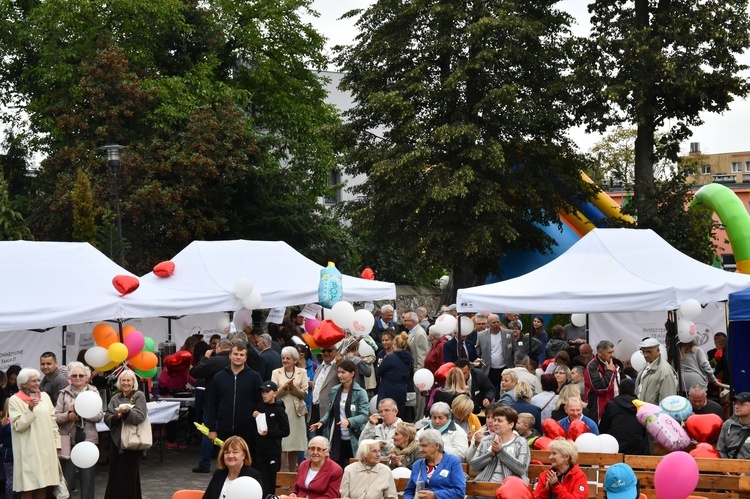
[338,0,589,285]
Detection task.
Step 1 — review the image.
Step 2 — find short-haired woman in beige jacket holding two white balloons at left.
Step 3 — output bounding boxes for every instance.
[55,362,104,499]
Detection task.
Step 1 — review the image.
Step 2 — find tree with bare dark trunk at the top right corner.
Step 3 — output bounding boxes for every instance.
[576,0,750,228]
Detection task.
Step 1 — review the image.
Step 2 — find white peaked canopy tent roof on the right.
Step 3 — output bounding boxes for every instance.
[456,229,750,313]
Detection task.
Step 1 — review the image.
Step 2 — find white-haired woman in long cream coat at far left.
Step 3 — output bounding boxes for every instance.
[8,368,60,499]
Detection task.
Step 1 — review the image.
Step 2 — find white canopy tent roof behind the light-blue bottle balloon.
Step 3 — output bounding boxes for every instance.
[131,240,396,317]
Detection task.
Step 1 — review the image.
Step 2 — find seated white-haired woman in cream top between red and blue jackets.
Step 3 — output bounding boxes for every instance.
[341,438,398,499]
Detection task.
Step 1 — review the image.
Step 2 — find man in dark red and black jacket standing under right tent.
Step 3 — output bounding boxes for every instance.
[583,340,619,423]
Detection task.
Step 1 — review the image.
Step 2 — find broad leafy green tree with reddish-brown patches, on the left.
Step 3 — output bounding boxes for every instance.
[0,0,346,272]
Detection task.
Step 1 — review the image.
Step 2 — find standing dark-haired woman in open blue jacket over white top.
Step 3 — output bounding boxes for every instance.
[310,360,370,469]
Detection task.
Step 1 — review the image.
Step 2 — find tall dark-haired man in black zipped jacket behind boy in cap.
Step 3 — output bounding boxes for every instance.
[206,343,263,466]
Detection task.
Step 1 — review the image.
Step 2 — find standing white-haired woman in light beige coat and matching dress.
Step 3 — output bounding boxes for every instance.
[271,346,310,472]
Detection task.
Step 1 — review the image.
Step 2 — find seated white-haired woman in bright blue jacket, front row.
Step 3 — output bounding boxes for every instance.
[404,429,466,499]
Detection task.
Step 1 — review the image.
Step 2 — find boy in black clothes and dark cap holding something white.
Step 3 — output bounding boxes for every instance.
[253,381,289,497]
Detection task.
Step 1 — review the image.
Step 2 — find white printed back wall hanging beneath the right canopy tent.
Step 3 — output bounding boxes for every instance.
[589,303,727,360]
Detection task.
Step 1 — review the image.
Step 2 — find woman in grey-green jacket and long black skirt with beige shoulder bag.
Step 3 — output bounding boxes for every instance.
[104,369,148,499]
